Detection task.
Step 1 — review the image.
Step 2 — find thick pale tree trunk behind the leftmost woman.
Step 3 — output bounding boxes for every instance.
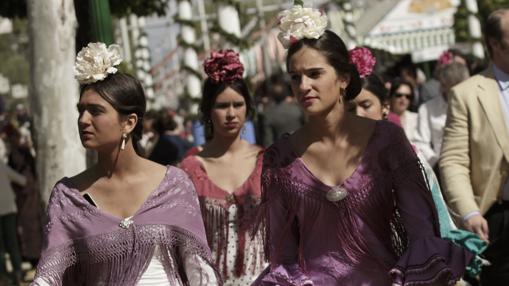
[27,0,85,202]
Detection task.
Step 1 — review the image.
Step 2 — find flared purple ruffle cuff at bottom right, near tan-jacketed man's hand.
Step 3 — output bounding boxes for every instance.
[389,237,473,286]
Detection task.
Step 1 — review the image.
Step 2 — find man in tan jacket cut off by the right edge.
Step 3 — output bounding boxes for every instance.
[439,9,509,286]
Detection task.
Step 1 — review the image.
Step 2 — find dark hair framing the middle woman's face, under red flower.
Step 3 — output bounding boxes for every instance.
[200,78,254,140]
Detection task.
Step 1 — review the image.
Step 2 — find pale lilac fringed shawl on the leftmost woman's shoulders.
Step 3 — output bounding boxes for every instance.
[31,167,218,285]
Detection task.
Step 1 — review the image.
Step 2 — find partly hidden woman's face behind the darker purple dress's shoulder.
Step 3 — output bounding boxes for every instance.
[347,88,388,120]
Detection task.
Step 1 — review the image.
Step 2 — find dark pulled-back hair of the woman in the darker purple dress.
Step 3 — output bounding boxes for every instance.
[286,30,361,101]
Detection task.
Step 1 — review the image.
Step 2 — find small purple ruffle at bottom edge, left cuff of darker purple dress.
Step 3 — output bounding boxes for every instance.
[252,264,314,286]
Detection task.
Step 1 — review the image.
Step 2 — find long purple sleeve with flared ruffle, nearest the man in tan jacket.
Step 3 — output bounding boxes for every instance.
[384,124,473,285]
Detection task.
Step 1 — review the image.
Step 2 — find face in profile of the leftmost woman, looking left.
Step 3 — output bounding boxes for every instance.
[78,89,123,150]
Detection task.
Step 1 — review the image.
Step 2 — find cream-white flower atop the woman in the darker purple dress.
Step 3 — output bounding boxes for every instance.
[278,5,329,49]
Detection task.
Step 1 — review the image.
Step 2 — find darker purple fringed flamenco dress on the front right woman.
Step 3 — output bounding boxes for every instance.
[253,121,472,286]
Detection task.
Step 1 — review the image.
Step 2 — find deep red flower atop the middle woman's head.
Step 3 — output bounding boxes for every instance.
[203,49,244,83]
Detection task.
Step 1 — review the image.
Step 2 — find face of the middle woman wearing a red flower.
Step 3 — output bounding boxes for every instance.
[210,87,247,140]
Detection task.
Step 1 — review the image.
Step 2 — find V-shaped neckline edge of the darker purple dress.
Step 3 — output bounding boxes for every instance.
[284,121,380,189]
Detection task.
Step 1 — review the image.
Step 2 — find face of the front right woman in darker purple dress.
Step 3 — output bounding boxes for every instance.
[288,46,348,115]
